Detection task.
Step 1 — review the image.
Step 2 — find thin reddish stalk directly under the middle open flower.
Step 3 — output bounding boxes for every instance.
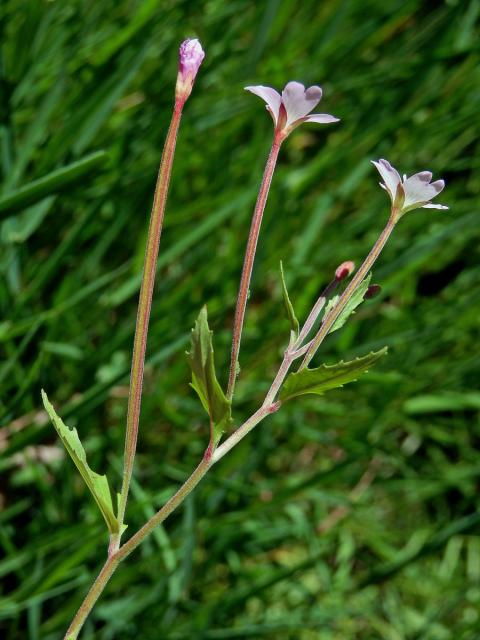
[227,134,282,400]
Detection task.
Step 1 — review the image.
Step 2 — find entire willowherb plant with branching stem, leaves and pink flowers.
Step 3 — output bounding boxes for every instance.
[42,39,447,640]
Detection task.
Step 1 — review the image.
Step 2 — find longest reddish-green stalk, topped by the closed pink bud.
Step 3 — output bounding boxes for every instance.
[114,100,185,536]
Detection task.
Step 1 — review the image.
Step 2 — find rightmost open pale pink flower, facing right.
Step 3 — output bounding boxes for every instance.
[372,159,448,219]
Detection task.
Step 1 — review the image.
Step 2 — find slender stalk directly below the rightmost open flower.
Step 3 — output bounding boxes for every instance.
[299,211,397,371]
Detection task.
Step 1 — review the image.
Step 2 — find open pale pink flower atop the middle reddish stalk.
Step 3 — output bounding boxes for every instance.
[245,81,339,139]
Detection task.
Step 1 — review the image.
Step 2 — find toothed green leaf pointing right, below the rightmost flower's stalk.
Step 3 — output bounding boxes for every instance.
[280,347,387,402]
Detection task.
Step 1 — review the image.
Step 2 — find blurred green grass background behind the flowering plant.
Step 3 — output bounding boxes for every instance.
[0,0,480,640]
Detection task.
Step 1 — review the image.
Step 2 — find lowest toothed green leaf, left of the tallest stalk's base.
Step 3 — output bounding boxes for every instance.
[42,390,118,533]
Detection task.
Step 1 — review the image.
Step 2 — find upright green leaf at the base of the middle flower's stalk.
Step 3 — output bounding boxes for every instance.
[187,307,232,444]
